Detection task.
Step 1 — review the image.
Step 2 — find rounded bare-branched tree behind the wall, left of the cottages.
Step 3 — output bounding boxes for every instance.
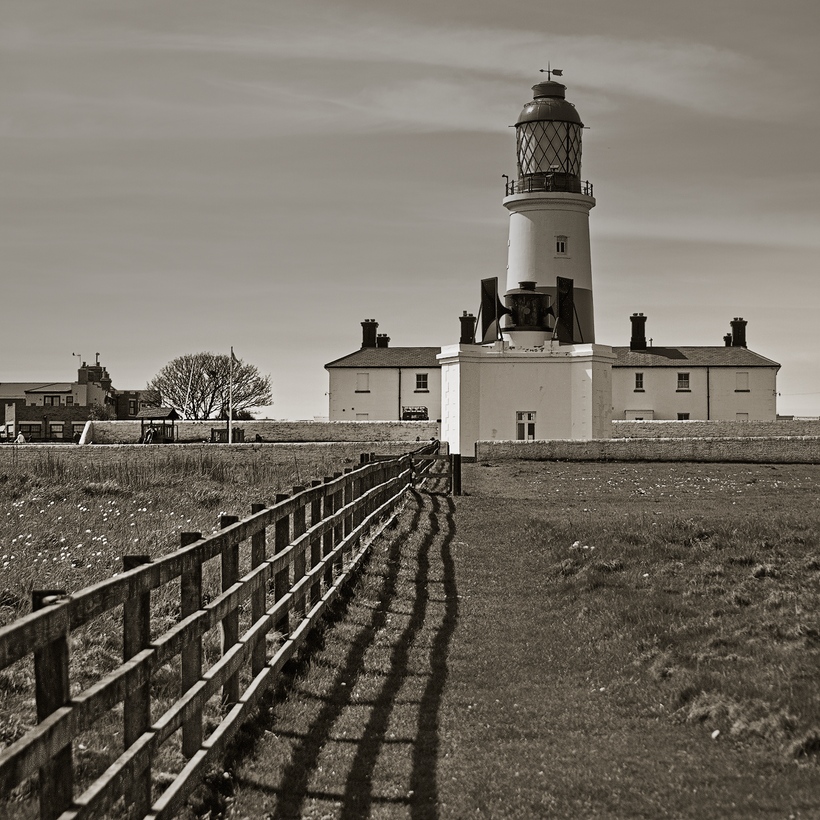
[147,353,273,419]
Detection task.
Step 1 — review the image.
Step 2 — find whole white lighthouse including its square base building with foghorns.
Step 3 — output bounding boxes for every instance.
[438,79,615,457]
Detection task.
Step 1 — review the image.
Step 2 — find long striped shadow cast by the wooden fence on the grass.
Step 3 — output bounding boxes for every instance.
[243,486,458,820]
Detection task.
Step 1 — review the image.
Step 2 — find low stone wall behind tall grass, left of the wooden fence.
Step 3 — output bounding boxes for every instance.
[0,441,416,474]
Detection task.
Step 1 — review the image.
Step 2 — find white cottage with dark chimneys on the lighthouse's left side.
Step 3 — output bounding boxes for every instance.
[325,319,441,421]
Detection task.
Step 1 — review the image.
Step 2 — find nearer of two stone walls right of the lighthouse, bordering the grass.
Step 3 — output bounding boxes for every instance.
[476,436,820,464]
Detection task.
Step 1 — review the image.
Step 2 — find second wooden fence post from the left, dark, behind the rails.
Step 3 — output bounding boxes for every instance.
[122,555,151,817]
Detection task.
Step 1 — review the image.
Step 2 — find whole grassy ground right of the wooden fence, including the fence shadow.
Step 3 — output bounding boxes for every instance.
[222,464,820,819]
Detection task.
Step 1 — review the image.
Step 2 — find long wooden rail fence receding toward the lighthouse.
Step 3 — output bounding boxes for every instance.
[0,442,438,820]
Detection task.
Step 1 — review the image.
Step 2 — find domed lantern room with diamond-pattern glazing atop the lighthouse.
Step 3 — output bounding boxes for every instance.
[515,80,584,193]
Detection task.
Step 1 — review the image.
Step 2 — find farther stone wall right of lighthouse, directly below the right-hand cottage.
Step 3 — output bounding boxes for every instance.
[612,419,820,439]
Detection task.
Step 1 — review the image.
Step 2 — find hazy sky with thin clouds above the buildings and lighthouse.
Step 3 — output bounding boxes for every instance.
[0,0,820,419]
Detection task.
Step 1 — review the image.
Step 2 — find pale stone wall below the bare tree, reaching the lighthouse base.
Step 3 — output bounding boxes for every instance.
[84,419,441,444]
